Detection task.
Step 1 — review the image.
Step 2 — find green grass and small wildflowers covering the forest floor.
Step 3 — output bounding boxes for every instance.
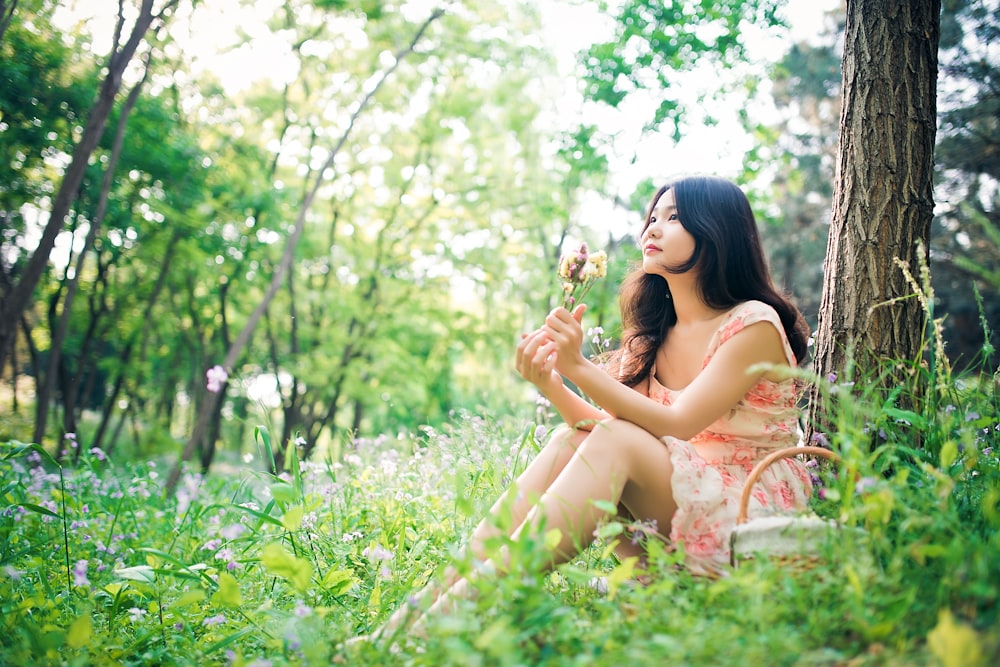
[0,366,1000,667]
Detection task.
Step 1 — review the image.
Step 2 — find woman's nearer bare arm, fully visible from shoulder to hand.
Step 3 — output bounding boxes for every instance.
[545,308,787,440]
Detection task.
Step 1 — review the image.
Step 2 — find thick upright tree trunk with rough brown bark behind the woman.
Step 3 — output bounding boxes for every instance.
[808,0,941,444]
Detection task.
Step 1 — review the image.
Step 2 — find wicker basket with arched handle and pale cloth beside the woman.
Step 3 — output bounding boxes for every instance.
[729,446,845,570]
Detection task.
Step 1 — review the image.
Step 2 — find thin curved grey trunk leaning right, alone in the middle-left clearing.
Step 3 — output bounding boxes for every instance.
[166,9,444,495]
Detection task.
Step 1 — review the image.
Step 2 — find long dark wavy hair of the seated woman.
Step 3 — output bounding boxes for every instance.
[619,176,809,386]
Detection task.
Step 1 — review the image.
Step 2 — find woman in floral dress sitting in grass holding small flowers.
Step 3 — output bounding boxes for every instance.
[372,177,809,640]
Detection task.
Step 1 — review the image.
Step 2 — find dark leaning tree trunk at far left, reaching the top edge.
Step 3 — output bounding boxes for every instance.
[0,0,178,374]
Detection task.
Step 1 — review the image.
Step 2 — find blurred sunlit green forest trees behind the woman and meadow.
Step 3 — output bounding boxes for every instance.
[0,0,1000,469]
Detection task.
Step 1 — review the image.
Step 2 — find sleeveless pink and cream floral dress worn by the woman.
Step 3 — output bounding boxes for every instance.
[649,301,811,574]
